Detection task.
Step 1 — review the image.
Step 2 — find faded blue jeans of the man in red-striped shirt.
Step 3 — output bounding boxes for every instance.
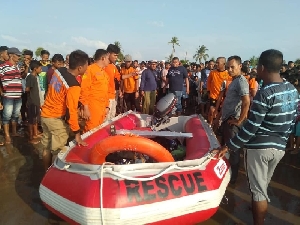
[2,97,22,124]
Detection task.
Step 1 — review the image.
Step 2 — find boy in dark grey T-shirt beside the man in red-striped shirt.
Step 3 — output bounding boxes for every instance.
[26,60,42,144]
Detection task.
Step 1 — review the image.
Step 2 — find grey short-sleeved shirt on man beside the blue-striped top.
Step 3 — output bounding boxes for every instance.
[222,76,249,121]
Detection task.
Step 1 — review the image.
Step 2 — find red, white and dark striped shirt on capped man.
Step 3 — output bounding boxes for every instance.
[0,61,23,98]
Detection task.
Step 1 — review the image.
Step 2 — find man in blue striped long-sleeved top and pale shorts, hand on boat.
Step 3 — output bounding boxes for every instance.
[213,49,299,225]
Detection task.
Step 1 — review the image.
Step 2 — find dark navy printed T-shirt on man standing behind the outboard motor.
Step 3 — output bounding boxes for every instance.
[167,66,188,91]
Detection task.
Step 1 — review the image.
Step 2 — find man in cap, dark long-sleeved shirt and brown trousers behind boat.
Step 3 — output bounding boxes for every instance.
[140,60,157,115]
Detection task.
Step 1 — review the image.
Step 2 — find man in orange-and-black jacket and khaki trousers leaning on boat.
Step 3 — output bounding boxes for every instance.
[41,50,89,170]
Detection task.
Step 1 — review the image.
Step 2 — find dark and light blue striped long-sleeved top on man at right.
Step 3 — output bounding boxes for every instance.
[226,81,299,151]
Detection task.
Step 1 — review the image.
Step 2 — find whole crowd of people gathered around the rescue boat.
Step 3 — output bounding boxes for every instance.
[0,44,300,224]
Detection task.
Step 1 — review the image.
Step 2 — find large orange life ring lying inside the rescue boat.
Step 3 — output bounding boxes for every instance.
[90,135,174,164]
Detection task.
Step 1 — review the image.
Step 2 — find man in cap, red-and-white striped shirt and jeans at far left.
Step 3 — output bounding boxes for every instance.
[0,47,23,144]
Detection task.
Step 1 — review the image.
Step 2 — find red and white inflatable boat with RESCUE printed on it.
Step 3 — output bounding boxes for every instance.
[39,94,230,225]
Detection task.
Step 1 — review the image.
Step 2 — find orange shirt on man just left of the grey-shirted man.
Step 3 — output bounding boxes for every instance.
[207,70,229,99]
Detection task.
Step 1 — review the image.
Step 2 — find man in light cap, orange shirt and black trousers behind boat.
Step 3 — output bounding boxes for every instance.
[121,55,139,110]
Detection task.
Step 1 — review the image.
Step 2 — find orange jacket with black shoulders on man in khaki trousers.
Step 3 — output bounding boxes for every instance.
[41,67,80,133]
